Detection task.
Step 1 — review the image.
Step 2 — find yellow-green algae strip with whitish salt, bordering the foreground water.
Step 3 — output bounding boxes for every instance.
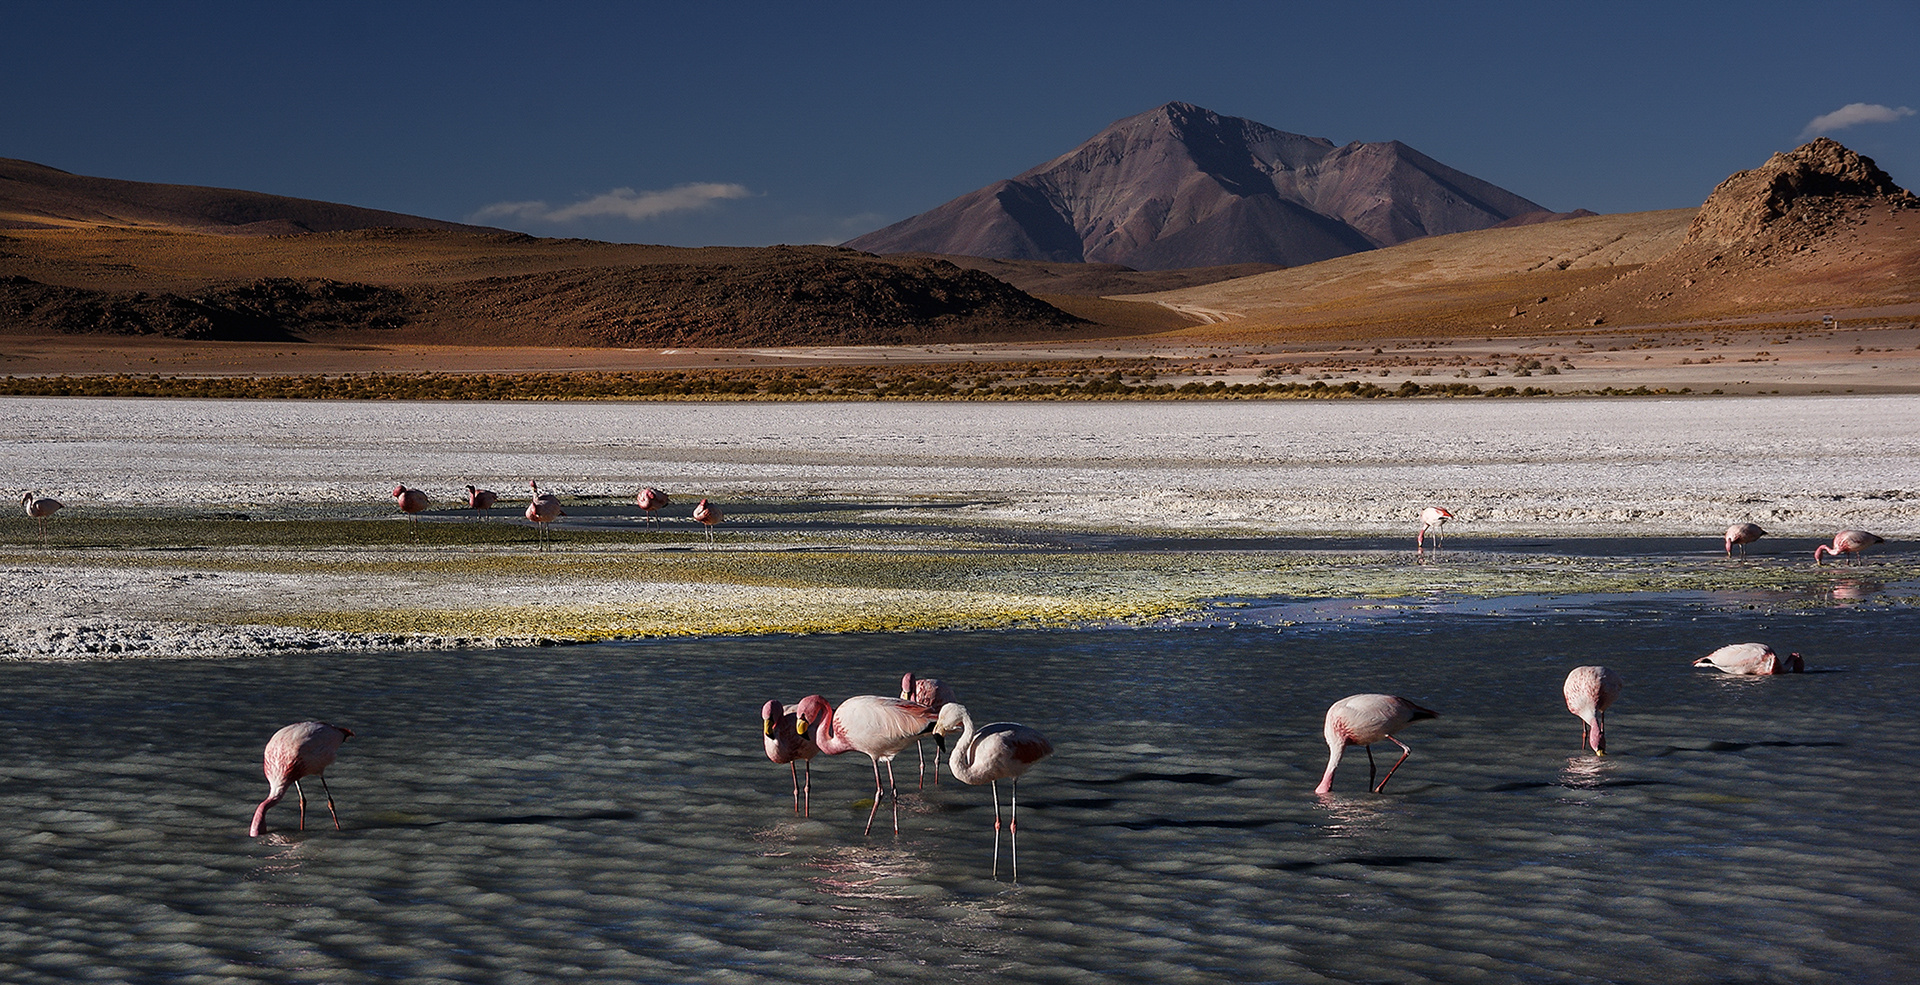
[0,513,1920,645]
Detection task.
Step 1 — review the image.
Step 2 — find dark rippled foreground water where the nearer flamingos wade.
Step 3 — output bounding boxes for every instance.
[0,595,1920,983]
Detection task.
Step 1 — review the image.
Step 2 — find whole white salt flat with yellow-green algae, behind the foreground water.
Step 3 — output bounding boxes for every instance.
[0,396,1920,657]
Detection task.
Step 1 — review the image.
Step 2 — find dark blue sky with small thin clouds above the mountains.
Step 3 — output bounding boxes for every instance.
[0,0,1920,246]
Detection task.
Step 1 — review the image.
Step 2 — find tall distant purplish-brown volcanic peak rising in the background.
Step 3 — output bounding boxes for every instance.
[847,102,1548,271]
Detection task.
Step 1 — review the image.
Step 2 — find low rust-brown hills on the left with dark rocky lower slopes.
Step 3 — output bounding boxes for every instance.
[0,161,1100,348]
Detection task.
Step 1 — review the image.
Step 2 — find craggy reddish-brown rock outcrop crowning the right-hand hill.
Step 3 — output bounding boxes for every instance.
[1686,136,1920,246]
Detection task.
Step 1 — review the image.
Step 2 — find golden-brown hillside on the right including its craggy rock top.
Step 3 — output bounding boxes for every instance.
[1142,138,1920,340]
